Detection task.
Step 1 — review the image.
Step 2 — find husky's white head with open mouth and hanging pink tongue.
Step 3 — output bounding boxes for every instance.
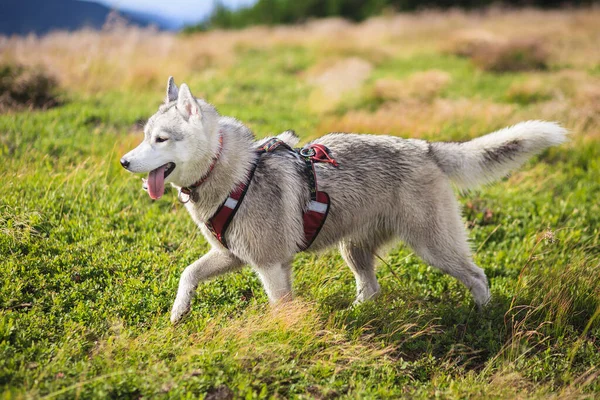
[121,77,219,199]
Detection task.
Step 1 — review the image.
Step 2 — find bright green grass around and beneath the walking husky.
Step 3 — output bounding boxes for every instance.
[0,44,600,399]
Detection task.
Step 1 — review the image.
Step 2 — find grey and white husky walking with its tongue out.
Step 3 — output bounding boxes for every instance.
[121,77,567,323]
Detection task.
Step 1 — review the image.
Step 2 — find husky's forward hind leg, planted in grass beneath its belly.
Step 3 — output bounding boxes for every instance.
[339,240,380,304]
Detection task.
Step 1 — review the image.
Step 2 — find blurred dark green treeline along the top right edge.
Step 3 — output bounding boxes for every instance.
[185,0,595,32]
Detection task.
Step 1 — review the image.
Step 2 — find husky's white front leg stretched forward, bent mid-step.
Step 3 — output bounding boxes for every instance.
[171,249,243,324]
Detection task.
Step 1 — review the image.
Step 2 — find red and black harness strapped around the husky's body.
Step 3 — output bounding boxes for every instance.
[197,138,338,250]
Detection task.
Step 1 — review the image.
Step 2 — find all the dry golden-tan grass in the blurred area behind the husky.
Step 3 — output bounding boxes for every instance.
[0,7,600,141]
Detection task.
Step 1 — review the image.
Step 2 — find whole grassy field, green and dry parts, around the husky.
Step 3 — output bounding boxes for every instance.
[0,9,600,399]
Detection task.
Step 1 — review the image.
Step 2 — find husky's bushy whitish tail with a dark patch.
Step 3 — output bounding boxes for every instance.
[429,121,568,189]
